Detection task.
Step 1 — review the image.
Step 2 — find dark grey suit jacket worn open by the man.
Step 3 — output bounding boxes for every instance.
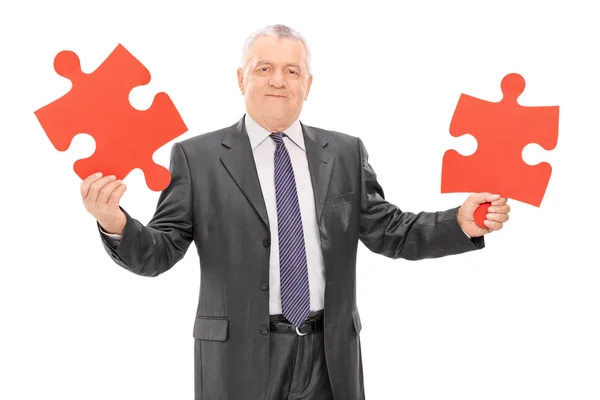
[100,117,484,400]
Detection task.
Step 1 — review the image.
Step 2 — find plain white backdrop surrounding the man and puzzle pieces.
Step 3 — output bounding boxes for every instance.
[0,0,600,400]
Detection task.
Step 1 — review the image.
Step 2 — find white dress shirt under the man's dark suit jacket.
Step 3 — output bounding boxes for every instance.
[105,114,325,315]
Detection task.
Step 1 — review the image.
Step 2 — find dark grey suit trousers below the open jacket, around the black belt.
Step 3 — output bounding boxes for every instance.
[265,310,334,400]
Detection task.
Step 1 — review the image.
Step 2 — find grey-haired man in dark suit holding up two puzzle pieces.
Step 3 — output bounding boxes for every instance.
[81,25,509,400]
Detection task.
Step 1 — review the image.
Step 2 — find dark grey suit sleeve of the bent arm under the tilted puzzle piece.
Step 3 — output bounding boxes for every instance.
[97,143,193,277]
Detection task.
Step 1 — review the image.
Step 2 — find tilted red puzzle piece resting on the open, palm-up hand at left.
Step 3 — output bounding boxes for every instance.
[35,44,187,191]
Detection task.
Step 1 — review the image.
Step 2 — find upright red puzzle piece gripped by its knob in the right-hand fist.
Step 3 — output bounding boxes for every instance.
[442,73,559,227]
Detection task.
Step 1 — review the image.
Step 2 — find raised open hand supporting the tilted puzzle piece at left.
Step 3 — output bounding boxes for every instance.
[80,172,127,235]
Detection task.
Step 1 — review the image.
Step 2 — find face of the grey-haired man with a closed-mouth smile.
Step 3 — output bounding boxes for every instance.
[238,36,312,131]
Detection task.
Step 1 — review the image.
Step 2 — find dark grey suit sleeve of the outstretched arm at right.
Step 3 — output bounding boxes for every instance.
[358,139,484,260]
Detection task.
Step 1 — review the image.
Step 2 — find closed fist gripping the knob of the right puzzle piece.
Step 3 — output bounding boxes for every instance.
[457,193,510,237]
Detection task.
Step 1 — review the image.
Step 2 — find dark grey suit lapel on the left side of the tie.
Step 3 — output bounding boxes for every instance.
[221,117,269,228]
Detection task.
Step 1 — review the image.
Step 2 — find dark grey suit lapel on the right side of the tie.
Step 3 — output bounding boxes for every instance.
[301,124,335,223]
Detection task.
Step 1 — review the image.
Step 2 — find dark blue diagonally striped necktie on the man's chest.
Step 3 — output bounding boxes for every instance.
[270,133,310,327]
